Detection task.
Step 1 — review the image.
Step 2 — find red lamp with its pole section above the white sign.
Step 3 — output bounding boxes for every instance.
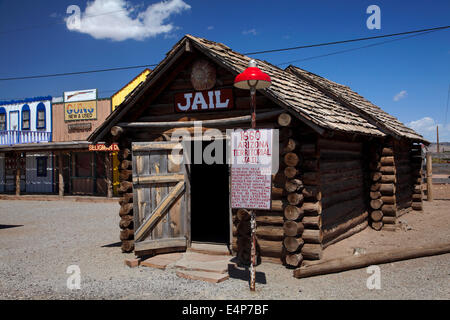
[234,60,271,129]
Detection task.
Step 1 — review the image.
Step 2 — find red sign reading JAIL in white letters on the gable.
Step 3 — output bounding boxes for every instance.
[175,89,233,112]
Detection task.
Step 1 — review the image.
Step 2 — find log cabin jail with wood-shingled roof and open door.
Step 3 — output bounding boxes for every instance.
[88,35,428,267]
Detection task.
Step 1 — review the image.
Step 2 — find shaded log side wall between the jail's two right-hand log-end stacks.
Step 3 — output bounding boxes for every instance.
[318,138,368,248]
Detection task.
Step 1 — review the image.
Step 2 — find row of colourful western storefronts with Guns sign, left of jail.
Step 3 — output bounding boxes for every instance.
[0,69,150,197]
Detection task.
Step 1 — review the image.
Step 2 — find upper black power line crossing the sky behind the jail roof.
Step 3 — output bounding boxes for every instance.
[0,26,450,81]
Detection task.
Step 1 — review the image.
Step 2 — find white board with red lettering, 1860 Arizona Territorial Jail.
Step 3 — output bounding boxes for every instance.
[231,129,273,210]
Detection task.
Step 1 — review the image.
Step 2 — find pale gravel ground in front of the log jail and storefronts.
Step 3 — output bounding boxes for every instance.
[0,200,450,300]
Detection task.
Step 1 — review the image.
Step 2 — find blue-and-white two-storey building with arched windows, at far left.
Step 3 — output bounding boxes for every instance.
[0,96,53,193]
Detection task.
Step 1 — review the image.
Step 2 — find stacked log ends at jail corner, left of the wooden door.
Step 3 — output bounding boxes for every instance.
[118,145,134,252]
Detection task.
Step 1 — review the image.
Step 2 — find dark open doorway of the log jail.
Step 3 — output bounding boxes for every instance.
[190,139,230,244]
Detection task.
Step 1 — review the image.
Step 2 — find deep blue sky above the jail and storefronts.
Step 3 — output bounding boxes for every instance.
[0,0,450,141]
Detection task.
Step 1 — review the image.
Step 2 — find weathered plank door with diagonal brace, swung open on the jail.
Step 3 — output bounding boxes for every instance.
[132,142,189,254]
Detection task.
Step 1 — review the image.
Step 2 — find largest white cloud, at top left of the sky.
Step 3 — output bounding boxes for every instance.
[65,0,191,41]
